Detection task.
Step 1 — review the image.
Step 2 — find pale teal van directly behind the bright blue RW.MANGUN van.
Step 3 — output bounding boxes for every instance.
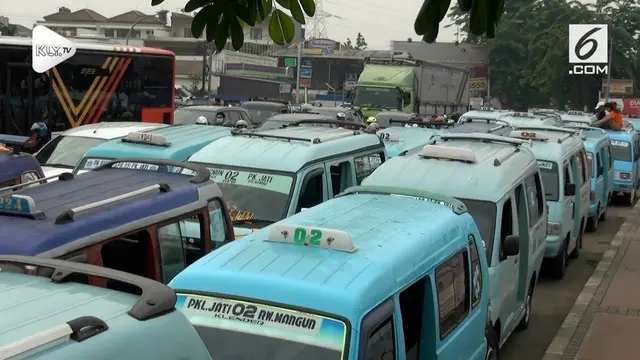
[363,133,547,354]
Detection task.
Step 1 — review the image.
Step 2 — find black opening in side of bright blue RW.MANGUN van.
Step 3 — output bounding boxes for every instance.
[400,278,427,360]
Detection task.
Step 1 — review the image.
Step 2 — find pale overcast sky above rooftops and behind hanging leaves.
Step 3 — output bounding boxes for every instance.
[0,0,456,50]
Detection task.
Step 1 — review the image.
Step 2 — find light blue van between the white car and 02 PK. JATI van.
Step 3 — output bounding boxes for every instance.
[74,125,231,174]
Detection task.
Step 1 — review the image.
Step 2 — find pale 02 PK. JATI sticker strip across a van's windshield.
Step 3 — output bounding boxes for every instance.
[209,168,293,194]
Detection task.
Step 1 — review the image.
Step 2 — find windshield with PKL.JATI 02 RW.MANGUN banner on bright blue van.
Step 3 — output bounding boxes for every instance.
[176,294,347,360]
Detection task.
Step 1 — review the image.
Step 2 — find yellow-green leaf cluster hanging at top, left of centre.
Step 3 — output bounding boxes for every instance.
[151,0,316,50]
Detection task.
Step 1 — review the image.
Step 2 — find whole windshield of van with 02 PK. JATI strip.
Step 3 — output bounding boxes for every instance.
[182,164,293,227]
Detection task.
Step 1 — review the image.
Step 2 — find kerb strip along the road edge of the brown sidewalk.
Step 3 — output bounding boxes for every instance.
[542,202,640,360]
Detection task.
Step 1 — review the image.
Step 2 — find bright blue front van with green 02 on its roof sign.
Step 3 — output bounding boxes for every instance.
[170,187,492,360]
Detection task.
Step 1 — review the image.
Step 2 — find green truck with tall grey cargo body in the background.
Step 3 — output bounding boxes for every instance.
[352,51,469,117]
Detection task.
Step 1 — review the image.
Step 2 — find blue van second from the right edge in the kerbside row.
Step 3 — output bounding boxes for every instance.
[565,125,614,231]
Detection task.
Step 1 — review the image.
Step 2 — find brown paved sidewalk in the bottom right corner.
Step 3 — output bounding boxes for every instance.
[542,202,640,360]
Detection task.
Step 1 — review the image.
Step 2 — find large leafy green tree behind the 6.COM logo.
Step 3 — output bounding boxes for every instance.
[449,0,640,109]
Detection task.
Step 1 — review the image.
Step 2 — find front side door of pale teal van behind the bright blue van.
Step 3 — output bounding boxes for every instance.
[490,193,526,345]
